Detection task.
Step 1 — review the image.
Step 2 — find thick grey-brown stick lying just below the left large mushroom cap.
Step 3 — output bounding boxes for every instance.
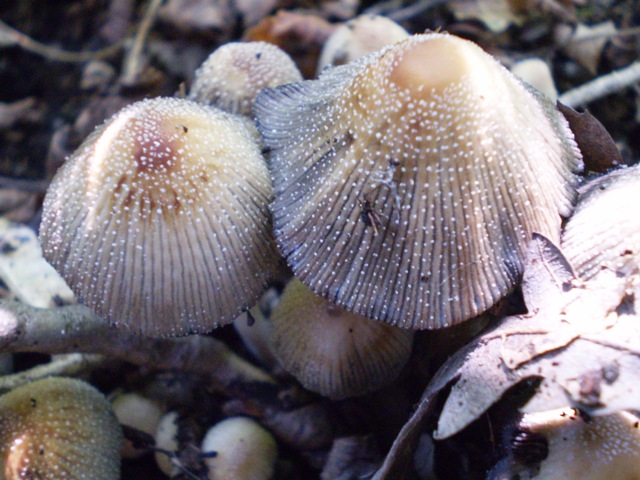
[0,300,275,392]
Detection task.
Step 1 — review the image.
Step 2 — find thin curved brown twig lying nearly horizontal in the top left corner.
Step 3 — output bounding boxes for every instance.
[0,20,122,63]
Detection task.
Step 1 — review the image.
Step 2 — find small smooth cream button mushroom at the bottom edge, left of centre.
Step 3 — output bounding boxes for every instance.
[201,417,278,480]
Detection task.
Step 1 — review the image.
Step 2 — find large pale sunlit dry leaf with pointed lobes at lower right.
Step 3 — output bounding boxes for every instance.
[375,235,640,478]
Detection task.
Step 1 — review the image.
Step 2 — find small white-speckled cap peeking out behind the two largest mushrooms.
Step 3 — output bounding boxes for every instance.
[189,42,302,116]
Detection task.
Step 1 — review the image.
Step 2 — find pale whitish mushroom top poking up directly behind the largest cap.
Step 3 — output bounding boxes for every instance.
[317,15,409,72]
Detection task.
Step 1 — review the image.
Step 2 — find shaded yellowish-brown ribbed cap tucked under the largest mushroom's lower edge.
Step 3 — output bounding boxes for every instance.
[271,278,414,399]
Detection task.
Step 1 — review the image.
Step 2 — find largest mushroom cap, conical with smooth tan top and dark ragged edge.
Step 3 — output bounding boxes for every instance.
[255,33,582,328]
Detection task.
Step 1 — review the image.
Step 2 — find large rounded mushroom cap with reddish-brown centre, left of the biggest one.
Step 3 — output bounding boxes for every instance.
[40,98,278,336]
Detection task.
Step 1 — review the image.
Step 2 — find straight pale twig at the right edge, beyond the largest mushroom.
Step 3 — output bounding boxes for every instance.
[558,61,640,108]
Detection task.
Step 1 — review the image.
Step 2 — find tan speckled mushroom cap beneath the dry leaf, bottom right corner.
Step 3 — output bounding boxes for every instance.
[521,408,640,480]
